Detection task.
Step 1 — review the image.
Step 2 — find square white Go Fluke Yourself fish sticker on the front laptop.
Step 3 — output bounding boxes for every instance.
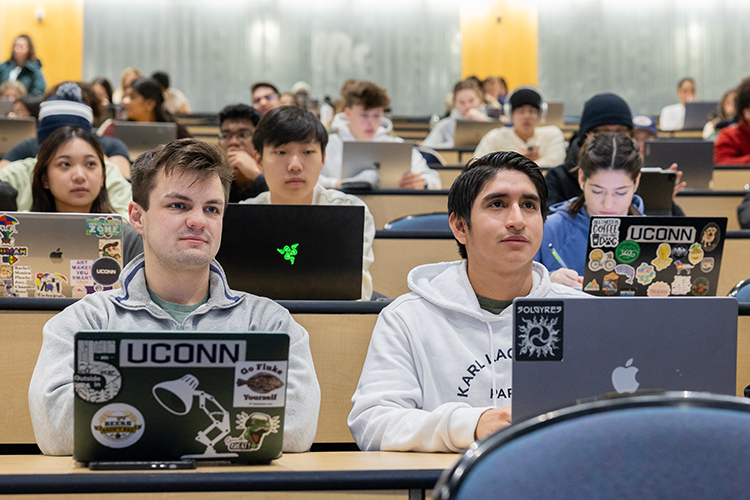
[233,361,287,408]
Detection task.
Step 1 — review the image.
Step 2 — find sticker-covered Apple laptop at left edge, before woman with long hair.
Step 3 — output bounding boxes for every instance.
[0,212,124,298]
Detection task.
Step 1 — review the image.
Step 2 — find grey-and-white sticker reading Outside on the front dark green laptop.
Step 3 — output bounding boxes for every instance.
[73,340,122,403]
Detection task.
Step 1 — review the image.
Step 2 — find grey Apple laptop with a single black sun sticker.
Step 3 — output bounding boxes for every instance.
[511,297,737,423]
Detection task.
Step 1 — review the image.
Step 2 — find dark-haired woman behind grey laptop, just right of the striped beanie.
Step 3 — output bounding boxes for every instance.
[98,78,192,139]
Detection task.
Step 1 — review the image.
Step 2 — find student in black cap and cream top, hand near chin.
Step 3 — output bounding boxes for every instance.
[474,85,565,167]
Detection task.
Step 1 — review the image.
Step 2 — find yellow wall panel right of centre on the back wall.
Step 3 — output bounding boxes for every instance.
[461,0,539,89]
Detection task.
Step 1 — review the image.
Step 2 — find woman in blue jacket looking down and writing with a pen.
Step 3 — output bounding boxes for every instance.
[534,132,643,288]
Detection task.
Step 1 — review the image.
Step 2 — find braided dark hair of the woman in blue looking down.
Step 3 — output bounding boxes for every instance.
[568,132,643,217]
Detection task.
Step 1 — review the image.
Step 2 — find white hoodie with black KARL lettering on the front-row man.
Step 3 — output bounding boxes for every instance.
[348,261,585,452]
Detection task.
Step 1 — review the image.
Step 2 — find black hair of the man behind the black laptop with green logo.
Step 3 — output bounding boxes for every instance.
[253,106,328,156]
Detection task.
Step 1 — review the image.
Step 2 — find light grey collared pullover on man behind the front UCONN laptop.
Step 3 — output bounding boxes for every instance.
[29,255,320,455]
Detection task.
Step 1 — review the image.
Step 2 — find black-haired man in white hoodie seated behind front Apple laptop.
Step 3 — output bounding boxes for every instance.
[348,151,585,452]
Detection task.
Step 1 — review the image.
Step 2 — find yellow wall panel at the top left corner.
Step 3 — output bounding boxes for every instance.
[0,0,83,92]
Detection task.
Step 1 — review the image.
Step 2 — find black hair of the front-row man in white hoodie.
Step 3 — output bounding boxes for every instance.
[448,151,547,259]
